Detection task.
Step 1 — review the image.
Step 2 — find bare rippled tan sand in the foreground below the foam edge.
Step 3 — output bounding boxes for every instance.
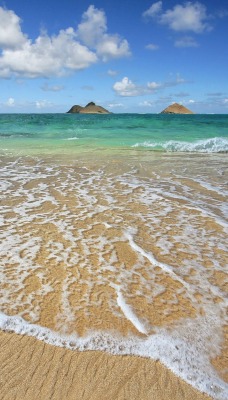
[0,332,210,400]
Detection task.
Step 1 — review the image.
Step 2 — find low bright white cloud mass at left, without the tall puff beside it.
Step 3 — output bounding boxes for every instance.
[0,29,97,78]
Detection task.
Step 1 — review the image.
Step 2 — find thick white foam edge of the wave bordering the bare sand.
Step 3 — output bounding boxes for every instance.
[0,312,228,400]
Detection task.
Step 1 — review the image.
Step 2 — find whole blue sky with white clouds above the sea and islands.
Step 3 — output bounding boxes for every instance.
[0,0,228,113]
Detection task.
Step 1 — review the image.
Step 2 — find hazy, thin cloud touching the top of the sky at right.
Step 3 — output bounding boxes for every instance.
[143,1,211,33]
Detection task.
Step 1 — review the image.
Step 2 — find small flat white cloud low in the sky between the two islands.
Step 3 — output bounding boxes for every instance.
[113,75,187,97]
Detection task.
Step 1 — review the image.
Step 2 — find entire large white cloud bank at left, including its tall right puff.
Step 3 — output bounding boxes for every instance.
[0,6,130,78]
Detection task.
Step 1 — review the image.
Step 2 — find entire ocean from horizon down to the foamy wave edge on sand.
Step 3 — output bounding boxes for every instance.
[0,114,228,400]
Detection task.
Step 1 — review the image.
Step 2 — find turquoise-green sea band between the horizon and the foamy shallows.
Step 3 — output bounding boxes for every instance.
[0,114,228,153]
